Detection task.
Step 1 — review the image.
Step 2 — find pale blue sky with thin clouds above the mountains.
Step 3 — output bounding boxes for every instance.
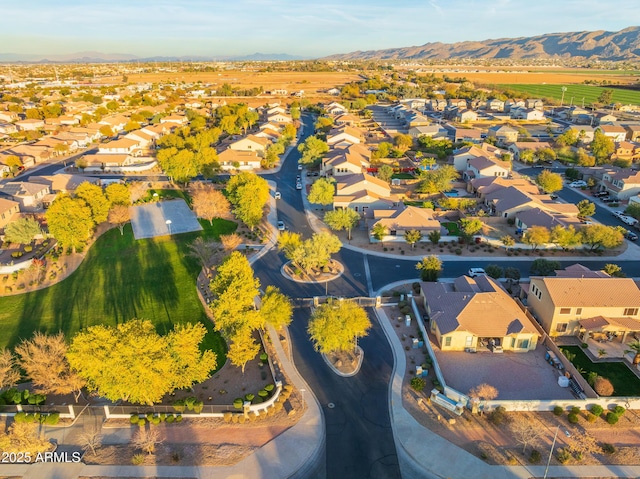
[0,0,640,57]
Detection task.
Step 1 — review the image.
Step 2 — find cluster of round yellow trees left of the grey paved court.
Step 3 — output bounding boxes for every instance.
[45,182,131,253]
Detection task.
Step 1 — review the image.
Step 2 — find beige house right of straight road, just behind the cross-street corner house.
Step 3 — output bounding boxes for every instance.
[333,173,398,218]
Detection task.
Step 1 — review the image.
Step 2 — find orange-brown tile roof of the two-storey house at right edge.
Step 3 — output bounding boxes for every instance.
[538,277,640,308]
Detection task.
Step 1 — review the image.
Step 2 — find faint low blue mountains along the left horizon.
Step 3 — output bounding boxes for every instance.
[0,52,305,63]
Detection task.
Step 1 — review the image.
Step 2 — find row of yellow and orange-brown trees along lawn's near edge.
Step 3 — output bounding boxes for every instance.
[0,319,217,405]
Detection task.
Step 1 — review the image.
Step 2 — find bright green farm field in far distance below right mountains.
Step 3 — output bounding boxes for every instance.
[498,83,640,106]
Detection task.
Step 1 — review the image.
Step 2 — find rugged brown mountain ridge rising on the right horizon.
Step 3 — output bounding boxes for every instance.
[324,27,640,61]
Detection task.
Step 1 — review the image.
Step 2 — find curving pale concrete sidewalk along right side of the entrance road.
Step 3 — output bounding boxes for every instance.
[376,308,640,479]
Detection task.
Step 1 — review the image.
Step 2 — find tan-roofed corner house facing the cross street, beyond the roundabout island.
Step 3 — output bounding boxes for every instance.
[369,204,441,242]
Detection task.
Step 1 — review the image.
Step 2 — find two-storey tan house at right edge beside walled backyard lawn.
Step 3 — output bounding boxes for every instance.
[527,265,640,343]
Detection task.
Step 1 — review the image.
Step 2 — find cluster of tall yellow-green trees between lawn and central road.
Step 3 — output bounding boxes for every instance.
[210,251,293,374]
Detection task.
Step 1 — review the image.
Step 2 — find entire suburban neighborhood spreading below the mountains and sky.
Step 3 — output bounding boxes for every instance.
[0,12,640,478]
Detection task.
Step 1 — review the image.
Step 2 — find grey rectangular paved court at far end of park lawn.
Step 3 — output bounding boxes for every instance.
[129,199,202,239]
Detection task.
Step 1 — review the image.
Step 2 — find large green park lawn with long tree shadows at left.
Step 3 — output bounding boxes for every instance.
[0,220,236,365]
